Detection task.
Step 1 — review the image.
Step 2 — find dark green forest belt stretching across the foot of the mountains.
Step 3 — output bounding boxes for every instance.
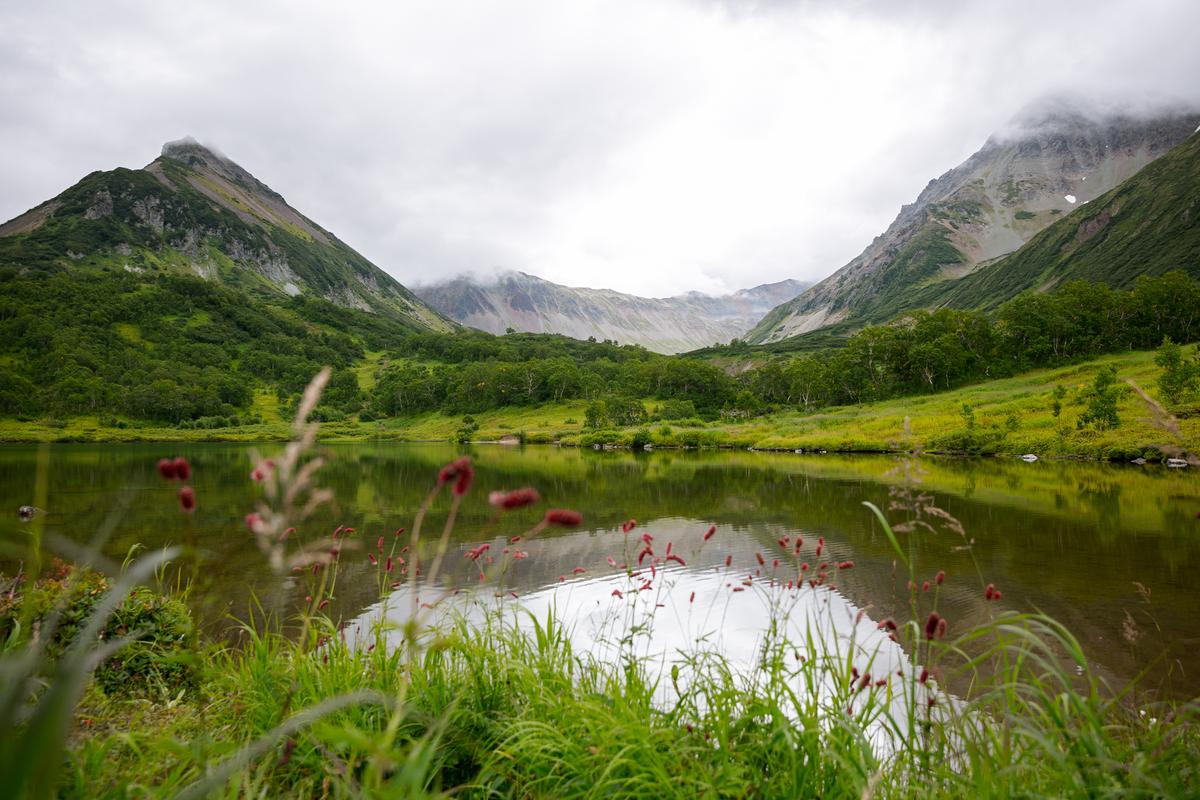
[0,263,1200,427]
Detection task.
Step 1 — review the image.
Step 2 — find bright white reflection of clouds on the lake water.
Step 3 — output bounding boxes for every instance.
[352,518,941,750]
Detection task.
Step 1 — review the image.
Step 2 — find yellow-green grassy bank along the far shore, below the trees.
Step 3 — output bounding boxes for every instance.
[7,353,1200,459]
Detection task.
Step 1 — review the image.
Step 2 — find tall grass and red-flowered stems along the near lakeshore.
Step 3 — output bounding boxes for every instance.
[0,373,1200,798]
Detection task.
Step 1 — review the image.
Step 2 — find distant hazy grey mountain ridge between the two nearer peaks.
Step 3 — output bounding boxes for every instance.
[415,272,808,353]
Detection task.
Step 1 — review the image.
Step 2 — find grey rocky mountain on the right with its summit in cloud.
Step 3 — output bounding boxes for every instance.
[746,100,1200,343]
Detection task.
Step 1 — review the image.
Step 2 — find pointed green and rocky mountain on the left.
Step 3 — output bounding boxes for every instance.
[0,139,454,330]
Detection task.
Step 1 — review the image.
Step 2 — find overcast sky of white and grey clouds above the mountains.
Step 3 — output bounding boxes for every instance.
[0,0,1200,296]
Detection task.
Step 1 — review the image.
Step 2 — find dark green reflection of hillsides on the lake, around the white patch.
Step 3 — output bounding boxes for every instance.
[0,444,1200,687]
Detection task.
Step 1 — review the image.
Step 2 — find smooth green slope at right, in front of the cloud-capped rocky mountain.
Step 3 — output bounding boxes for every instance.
[934,128,1200,308]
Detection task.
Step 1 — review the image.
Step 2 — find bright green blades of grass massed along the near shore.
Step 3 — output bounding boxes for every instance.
[60,582,1200,799]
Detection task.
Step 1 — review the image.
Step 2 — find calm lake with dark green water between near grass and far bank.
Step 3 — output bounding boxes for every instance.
[0,443,1200,697]
